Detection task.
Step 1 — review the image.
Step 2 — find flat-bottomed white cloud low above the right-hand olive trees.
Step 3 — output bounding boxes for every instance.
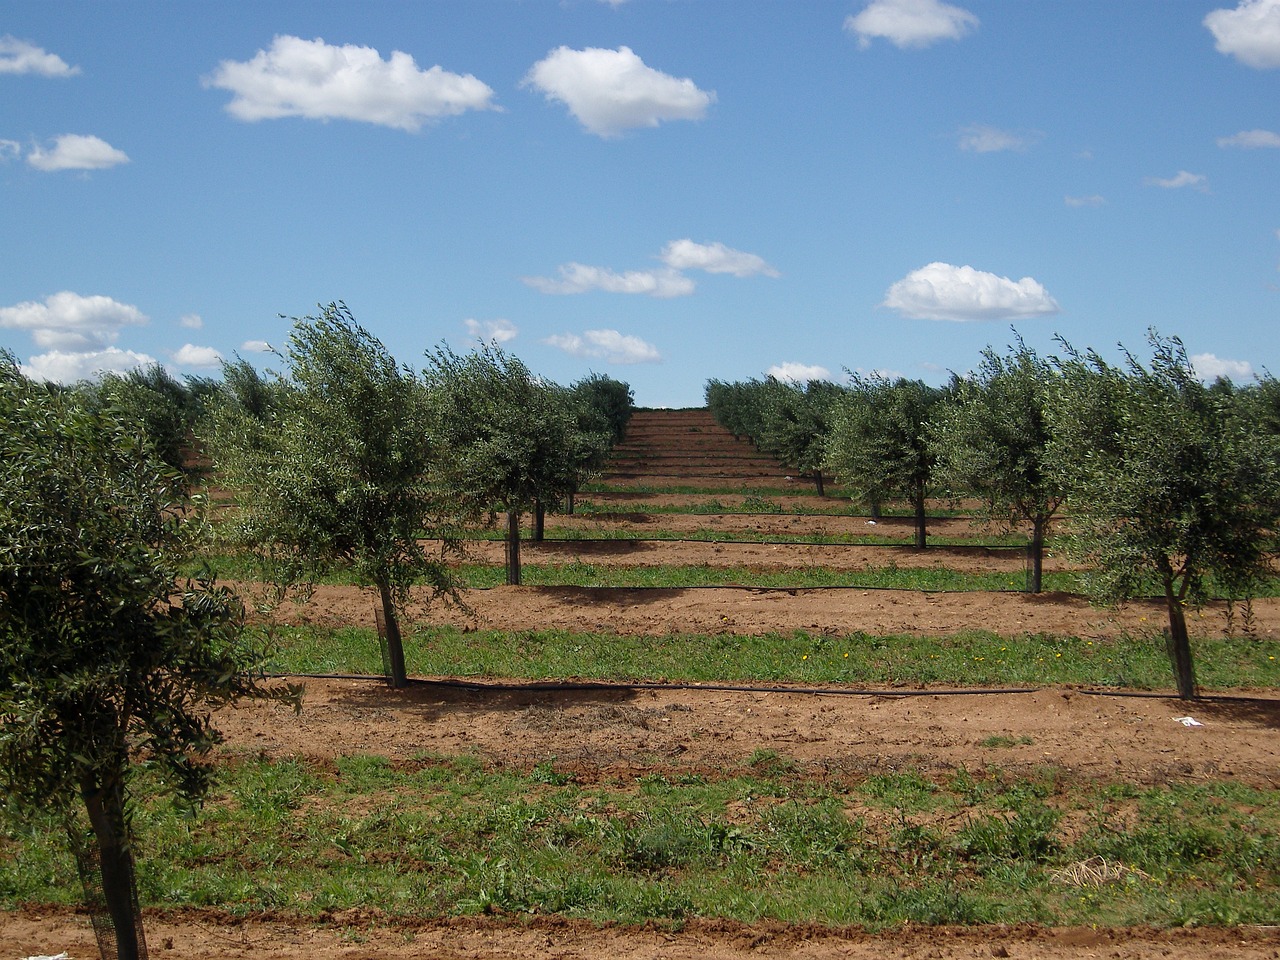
[881,262,1060,321]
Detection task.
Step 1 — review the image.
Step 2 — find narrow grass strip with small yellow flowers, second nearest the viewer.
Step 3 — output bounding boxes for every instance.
[259,620,1280,692]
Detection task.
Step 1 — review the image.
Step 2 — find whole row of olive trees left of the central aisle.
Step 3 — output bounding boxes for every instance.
[0,303,631,960]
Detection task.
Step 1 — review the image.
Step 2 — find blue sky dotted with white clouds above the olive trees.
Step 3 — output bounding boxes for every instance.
[0,0,1280,406]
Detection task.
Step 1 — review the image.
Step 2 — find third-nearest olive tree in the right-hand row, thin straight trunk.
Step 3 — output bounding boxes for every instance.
[824,375,945,550]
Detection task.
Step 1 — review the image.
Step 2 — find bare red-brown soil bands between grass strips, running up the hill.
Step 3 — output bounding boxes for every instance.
[12,411,1280,960]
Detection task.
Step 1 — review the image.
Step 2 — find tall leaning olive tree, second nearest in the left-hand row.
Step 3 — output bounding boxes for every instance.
[209,303,456,687]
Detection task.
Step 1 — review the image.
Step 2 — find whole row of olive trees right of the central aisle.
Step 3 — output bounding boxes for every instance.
[707,332,1280,698]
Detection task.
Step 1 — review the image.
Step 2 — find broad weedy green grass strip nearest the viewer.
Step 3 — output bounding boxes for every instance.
[0,751,1280,929]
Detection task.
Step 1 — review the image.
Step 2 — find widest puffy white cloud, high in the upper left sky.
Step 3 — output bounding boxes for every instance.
[204,36,494,132]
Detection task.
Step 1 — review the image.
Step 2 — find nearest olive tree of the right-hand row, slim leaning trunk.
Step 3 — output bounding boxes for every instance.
[1048,332,1280,699]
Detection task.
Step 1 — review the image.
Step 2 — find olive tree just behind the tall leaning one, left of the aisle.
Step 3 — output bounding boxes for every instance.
[426,344,608,585]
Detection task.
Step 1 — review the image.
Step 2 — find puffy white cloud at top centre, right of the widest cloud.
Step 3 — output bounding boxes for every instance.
[521,46,716,137]
